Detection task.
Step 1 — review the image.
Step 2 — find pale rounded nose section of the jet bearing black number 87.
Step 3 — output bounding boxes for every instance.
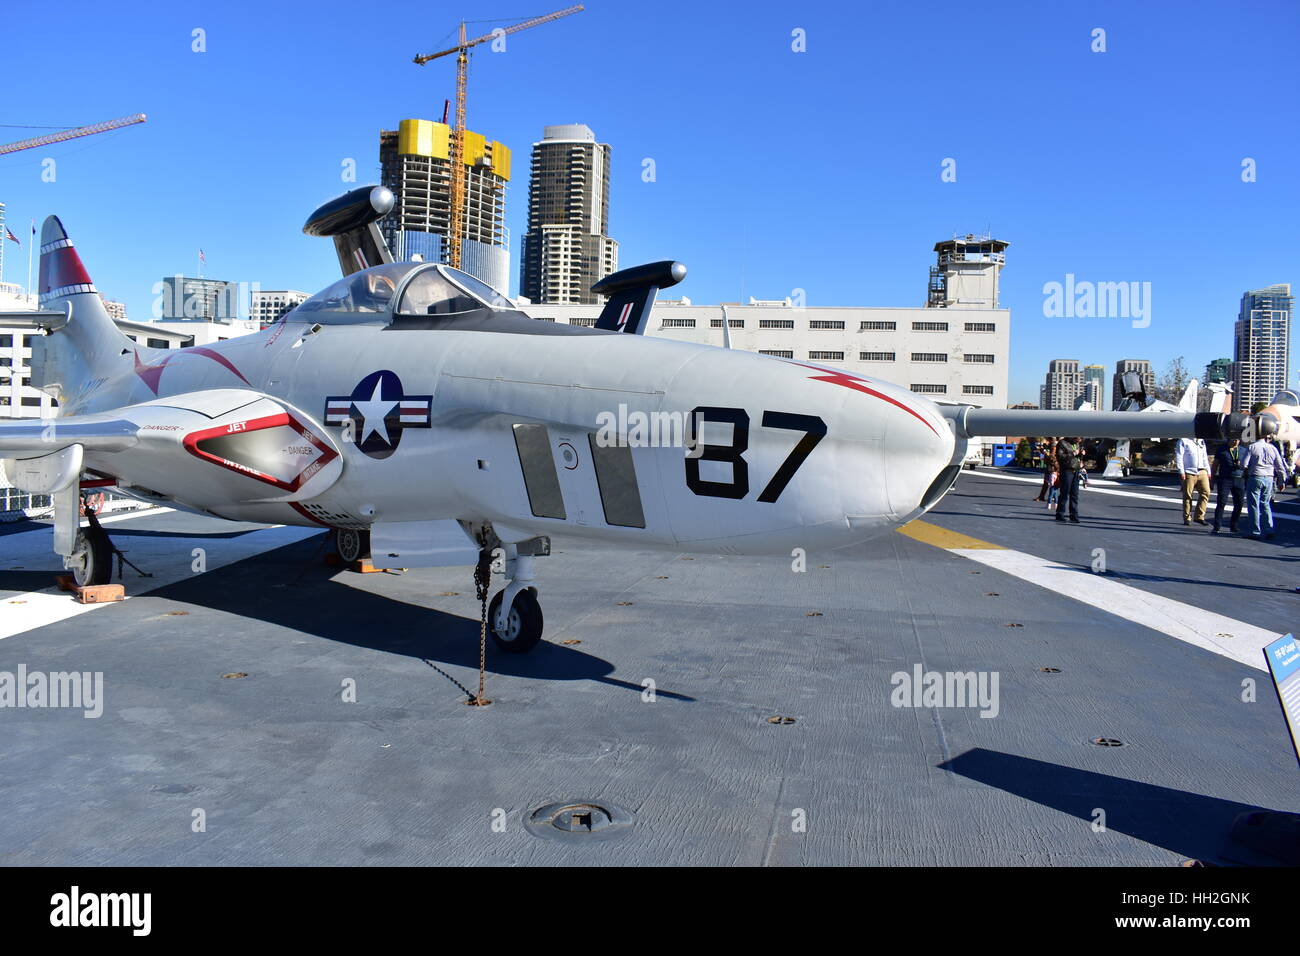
[664,350,954,553]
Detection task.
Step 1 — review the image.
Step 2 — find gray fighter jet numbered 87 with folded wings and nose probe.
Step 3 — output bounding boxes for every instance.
[0,187,1256,652]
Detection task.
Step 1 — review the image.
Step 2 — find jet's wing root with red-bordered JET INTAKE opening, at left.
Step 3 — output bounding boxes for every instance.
[0,389,343,509]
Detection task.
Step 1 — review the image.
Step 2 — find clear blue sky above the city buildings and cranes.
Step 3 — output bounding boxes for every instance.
[0,0,1300,401]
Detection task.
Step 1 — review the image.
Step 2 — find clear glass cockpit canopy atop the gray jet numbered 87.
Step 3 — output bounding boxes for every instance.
[294,263,514,324]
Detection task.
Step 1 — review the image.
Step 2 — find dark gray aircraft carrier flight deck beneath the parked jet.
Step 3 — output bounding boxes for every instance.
[0,468,1300,866]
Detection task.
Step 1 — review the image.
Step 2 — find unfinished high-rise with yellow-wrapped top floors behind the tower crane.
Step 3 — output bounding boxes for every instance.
[380,120,511,294]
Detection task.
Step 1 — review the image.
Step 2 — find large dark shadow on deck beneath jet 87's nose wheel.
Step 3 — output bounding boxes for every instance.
[139,536,696,702]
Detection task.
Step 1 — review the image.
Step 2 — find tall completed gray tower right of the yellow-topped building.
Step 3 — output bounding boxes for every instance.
[519,124,619,303]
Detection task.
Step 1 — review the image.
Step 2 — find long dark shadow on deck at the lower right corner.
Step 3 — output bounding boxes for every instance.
[939,748,1277,865]
